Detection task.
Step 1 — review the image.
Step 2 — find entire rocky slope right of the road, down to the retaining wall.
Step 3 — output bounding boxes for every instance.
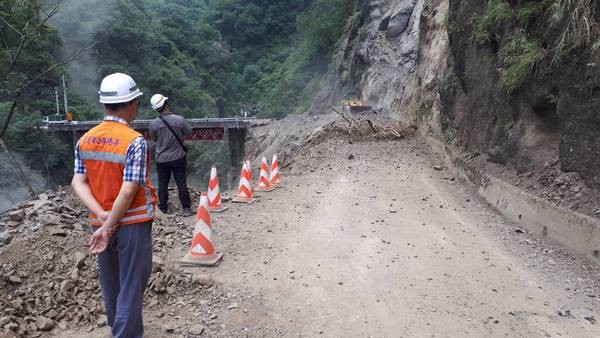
[313,0,600,214]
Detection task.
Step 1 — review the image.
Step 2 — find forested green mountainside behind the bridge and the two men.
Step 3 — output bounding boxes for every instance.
[0,0,356,183]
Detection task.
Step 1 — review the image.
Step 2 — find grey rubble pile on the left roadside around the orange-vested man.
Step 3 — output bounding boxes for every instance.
[0,189,244,337]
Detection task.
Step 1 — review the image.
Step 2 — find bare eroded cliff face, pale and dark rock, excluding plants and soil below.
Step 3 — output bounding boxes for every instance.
[324,0,600,188]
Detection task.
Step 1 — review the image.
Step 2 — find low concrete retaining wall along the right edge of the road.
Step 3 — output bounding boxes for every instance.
[424,135,600,264]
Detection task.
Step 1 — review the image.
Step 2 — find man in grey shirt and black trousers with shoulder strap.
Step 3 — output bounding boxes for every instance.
[150,94,194,216]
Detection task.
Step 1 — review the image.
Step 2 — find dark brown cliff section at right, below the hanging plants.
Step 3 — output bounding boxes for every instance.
[440,0,600,188]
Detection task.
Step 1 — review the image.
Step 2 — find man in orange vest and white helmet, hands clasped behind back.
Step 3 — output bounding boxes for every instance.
[71,73,156,338]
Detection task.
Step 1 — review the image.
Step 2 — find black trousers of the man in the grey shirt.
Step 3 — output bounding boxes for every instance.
[156,157,192,210]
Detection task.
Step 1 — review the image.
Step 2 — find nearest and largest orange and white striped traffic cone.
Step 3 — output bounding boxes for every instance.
[180,193,223,266]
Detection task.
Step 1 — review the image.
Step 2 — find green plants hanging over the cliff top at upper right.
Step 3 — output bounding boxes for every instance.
[469,0,600,93]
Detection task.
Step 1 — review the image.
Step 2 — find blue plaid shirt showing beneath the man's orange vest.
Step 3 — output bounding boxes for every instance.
[75,115,148,184]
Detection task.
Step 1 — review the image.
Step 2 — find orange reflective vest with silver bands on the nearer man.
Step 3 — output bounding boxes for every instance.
[79,121,156,227]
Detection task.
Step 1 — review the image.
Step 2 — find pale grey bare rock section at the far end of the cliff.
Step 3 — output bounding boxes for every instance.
[316,0,425,112]
